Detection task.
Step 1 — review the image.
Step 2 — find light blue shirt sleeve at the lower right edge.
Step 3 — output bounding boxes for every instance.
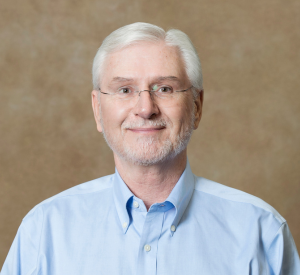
[267,223,300,275]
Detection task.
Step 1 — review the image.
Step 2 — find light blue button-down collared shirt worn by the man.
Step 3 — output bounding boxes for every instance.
[1,164,300,275]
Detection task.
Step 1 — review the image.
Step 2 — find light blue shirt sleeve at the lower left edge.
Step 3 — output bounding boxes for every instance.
[1,208,43,275]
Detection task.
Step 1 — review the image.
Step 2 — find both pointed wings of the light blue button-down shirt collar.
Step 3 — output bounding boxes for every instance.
[113,161,195,236]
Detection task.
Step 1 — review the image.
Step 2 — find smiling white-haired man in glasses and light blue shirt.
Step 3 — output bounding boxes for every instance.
[1,23,300,275]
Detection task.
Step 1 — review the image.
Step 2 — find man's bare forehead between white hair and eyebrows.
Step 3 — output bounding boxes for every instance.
[101,42,187,85]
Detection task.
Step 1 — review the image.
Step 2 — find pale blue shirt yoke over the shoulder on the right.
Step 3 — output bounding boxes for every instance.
[195,176,286,224]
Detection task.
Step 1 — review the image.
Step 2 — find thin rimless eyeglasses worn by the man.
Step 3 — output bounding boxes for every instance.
[99,85,193,100]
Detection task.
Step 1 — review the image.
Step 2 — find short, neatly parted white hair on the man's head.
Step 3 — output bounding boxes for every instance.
[93,22,203,90]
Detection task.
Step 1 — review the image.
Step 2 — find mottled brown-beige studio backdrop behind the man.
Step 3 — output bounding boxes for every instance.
[0,0,300,266]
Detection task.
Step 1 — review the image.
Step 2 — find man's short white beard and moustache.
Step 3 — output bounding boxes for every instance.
[100,110,195,166]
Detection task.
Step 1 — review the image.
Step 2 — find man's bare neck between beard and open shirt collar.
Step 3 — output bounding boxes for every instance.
[114,150,187,210]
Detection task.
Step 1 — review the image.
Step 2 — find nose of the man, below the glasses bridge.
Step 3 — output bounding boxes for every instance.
[133,90,159,119]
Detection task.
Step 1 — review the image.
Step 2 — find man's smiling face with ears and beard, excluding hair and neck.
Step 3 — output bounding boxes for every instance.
[92,42,202,165]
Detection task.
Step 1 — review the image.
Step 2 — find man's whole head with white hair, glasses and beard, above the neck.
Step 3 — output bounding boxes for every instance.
[92,23,203,165]
